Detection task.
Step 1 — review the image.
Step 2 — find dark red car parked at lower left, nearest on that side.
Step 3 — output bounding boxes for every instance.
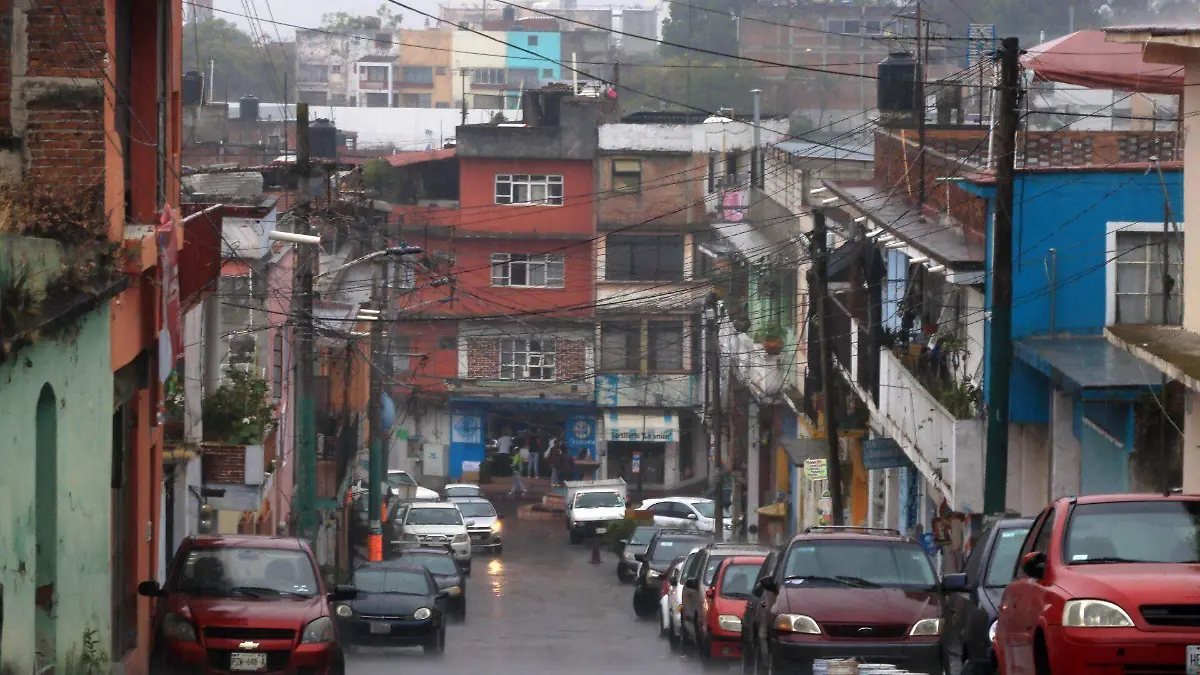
[138,534,358,675]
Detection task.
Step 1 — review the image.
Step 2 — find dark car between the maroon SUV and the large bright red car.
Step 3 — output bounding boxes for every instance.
[943,518,1033,675]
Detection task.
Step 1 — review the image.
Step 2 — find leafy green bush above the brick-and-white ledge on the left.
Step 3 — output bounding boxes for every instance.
[203,369,275,446]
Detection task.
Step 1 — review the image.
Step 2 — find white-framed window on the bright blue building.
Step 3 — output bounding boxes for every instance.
[1114,232,1183,324]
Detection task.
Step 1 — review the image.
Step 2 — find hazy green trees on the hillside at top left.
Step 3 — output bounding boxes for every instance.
[182,19,295,103]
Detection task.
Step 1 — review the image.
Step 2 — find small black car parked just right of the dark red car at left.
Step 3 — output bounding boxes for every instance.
[334,561,446,656]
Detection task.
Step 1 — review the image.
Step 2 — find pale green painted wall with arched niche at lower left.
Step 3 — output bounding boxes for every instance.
[0,301,113,675]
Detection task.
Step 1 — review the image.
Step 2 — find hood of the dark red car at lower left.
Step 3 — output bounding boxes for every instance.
[172,596,329,631]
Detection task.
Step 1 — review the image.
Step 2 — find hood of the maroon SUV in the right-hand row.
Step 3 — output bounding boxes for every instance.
[780,583,942,623]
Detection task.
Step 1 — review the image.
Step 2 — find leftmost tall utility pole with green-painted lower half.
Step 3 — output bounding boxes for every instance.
[292,103,317,543]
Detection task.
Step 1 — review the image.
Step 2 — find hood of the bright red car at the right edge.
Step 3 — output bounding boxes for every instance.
[1055,563,1200,607]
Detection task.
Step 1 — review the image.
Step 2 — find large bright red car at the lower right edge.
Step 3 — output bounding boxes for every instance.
[996,495,1200,675]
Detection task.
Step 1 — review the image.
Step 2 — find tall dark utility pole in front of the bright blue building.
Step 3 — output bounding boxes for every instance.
[983,37,1020,513]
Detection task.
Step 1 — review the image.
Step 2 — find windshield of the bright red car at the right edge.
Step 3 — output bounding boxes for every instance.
[1063,500,1200,565]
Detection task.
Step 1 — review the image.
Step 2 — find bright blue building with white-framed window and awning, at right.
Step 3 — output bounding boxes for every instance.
[961,167,1182,499]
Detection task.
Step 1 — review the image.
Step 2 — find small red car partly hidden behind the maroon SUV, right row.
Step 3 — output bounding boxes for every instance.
[697,555,767,659]
